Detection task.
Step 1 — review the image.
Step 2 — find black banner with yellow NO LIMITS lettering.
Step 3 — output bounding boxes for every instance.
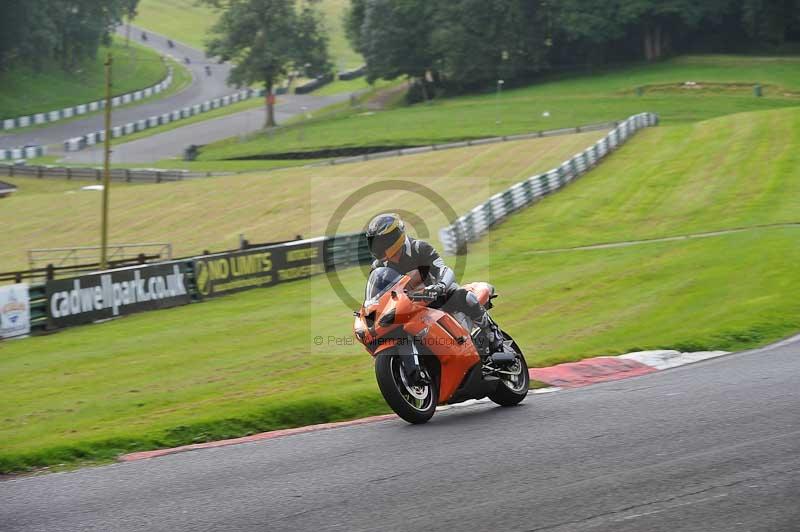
[194,239,325,298]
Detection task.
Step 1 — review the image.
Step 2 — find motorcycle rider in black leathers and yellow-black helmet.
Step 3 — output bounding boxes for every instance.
[366,213,503,355]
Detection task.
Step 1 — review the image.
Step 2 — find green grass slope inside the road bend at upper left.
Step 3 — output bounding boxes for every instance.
[0,39,167,119]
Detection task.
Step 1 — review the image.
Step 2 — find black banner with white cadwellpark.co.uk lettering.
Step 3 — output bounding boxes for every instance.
[46,263,191,327]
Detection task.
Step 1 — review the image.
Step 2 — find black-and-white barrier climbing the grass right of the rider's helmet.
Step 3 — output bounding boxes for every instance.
[439,113,658,253]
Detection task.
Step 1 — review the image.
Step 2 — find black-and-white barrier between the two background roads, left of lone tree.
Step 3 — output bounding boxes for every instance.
[64,85,268,152]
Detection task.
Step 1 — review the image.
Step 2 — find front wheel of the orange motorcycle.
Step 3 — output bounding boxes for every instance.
[375,353,439,424]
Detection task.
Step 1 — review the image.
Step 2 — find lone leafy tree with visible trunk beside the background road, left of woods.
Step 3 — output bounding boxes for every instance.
[203,0,330,127]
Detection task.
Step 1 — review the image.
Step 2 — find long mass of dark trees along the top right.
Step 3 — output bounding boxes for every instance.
[345,0,800,98]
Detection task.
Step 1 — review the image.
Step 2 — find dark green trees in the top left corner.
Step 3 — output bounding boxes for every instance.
[0,0,139,71]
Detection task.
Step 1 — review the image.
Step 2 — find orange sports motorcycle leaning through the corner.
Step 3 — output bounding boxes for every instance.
[353,267,530,423]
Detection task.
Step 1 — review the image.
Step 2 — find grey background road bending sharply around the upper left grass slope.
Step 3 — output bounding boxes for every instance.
[0,26,235,148]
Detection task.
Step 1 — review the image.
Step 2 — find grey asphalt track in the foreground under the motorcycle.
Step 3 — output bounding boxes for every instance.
[0,337,800,532]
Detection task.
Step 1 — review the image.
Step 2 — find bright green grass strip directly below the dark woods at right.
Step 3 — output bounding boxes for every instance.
[200,56,800,160]
